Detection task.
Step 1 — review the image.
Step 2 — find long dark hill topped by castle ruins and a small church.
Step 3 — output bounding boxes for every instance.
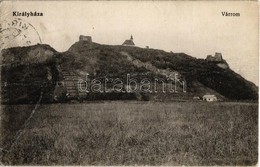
[1,41,258,103]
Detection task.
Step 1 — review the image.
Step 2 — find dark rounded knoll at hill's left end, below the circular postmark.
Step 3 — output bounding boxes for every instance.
[1,45,58,104]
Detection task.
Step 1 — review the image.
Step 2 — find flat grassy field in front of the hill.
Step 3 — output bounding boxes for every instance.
[1,102,258,165]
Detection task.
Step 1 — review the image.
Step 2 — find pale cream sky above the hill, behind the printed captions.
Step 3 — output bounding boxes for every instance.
[1,1,259,85]
